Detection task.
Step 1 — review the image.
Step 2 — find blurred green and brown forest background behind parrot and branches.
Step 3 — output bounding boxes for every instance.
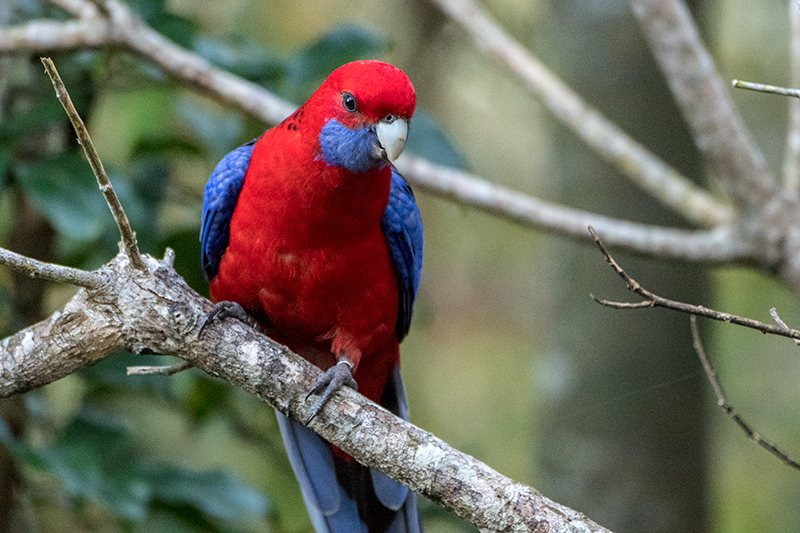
[0,0,800,532]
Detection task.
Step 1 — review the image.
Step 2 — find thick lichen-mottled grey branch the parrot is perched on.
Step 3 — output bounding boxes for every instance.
[0,253,606,531]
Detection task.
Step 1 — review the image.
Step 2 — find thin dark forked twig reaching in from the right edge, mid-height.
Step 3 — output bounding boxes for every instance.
[589,226,800,339]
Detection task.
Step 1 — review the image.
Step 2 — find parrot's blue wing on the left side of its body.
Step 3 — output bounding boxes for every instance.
[200,141,256,281]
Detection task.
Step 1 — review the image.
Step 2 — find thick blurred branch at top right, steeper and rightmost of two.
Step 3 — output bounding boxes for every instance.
[630,0,776,208]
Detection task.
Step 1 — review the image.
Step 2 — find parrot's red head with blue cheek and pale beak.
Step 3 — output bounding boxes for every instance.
[304,61,416,172]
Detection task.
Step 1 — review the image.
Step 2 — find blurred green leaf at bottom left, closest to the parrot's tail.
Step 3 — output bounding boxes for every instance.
[148,464,269,522]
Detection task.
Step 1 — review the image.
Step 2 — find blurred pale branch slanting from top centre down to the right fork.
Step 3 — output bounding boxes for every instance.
[435,0,730,227]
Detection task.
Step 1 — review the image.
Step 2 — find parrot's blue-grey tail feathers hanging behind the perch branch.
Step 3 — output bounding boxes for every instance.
[276,367,422,533]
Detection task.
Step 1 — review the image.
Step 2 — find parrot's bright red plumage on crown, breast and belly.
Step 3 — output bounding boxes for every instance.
[211,62,416,401]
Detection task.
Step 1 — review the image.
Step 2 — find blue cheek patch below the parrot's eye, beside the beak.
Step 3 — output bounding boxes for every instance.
[319,119,385,173]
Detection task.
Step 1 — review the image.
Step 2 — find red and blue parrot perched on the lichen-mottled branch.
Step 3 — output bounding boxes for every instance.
[200,60,424,533]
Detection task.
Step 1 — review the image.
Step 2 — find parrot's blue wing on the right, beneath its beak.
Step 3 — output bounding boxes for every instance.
[381,167,424,340]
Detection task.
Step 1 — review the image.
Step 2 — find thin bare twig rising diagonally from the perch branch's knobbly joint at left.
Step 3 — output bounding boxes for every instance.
[42,57,146,270]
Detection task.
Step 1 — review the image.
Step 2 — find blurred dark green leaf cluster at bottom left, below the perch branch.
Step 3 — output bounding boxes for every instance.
[0,408,268,531]
